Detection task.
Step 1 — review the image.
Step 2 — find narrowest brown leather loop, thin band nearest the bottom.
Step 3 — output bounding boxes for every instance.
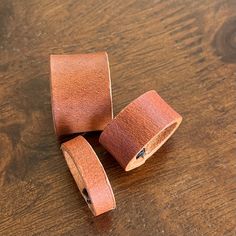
[61,136,116,216]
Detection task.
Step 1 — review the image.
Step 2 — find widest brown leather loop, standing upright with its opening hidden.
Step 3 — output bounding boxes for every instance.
[50,52,113,136]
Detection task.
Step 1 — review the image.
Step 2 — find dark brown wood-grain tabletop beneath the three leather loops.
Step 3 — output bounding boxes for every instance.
[0,0,236,236]
